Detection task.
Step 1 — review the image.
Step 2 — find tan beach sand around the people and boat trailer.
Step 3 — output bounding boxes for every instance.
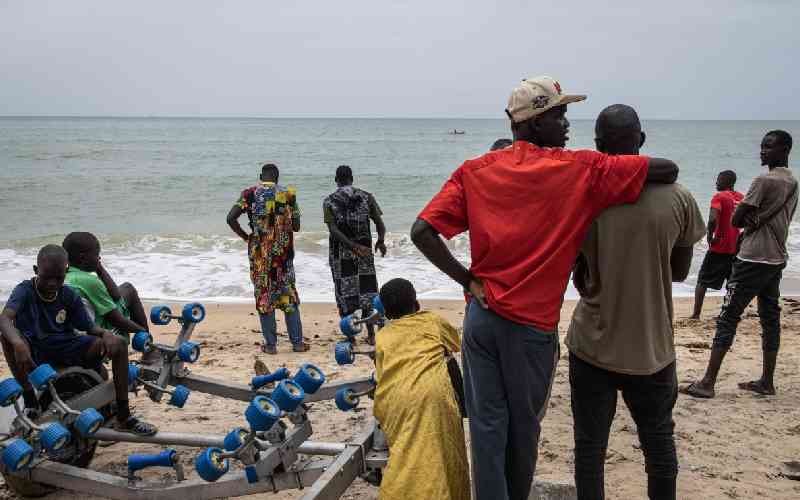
[0,298,800,500]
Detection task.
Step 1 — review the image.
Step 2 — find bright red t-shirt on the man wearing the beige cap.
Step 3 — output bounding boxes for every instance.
[419,141,648,331]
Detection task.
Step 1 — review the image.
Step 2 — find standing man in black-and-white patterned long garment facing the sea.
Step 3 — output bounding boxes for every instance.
[322,165,386,343]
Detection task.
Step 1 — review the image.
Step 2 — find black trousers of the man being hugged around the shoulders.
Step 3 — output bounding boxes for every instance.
[569,353,678,500]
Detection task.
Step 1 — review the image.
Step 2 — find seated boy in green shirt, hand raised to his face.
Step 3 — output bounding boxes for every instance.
[62,233,150,342]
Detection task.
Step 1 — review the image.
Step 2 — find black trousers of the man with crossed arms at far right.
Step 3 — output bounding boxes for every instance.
[714,259,786,352]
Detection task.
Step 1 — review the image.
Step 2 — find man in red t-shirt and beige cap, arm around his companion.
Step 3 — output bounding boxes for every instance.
[411,77,678,500]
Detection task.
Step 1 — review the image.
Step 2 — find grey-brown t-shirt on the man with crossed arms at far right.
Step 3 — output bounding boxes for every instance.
[738,167,797,265]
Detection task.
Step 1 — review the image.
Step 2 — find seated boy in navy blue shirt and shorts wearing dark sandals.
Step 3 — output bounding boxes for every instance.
[0,245,157,436]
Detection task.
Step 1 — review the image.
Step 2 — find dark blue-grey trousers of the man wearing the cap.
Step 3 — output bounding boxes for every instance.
[462,301,558,500]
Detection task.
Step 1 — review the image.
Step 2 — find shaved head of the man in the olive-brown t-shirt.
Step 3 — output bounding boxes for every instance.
[594,104,644,154]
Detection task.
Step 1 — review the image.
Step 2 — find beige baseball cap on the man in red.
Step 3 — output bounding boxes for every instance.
[506,76,586,123]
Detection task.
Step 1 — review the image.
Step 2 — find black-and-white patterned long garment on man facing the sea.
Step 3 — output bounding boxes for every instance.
[322,186,381,316]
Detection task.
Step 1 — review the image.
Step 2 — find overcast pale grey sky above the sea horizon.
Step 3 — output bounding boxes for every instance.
[0,0,800,119]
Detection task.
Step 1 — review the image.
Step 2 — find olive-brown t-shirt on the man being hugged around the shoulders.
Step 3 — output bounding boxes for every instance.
[566,184,705,375]
